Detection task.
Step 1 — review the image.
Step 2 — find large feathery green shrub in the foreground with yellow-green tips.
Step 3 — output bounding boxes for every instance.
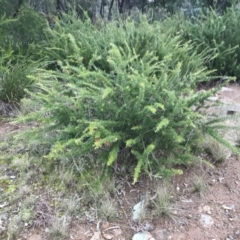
[16,16,238,182]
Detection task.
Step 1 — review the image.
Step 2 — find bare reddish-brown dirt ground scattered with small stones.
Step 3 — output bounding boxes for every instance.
[0,85,240,240]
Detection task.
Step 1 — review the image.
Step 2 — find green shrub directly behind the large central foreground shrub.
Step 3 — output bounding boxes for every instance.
[37,13,215,75]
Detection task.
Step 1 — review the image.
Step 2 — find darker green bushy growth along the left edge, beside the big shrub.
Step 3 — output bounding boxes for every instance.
[0,5,47,109]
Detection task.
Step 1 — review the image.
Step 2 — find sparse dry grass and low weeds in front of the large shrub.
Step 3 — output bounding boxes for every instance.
[0,118,239,239]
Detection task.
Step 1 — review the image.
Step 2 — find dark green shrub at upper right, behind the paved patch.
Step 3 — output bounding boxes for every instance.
[161,7,240,78]
